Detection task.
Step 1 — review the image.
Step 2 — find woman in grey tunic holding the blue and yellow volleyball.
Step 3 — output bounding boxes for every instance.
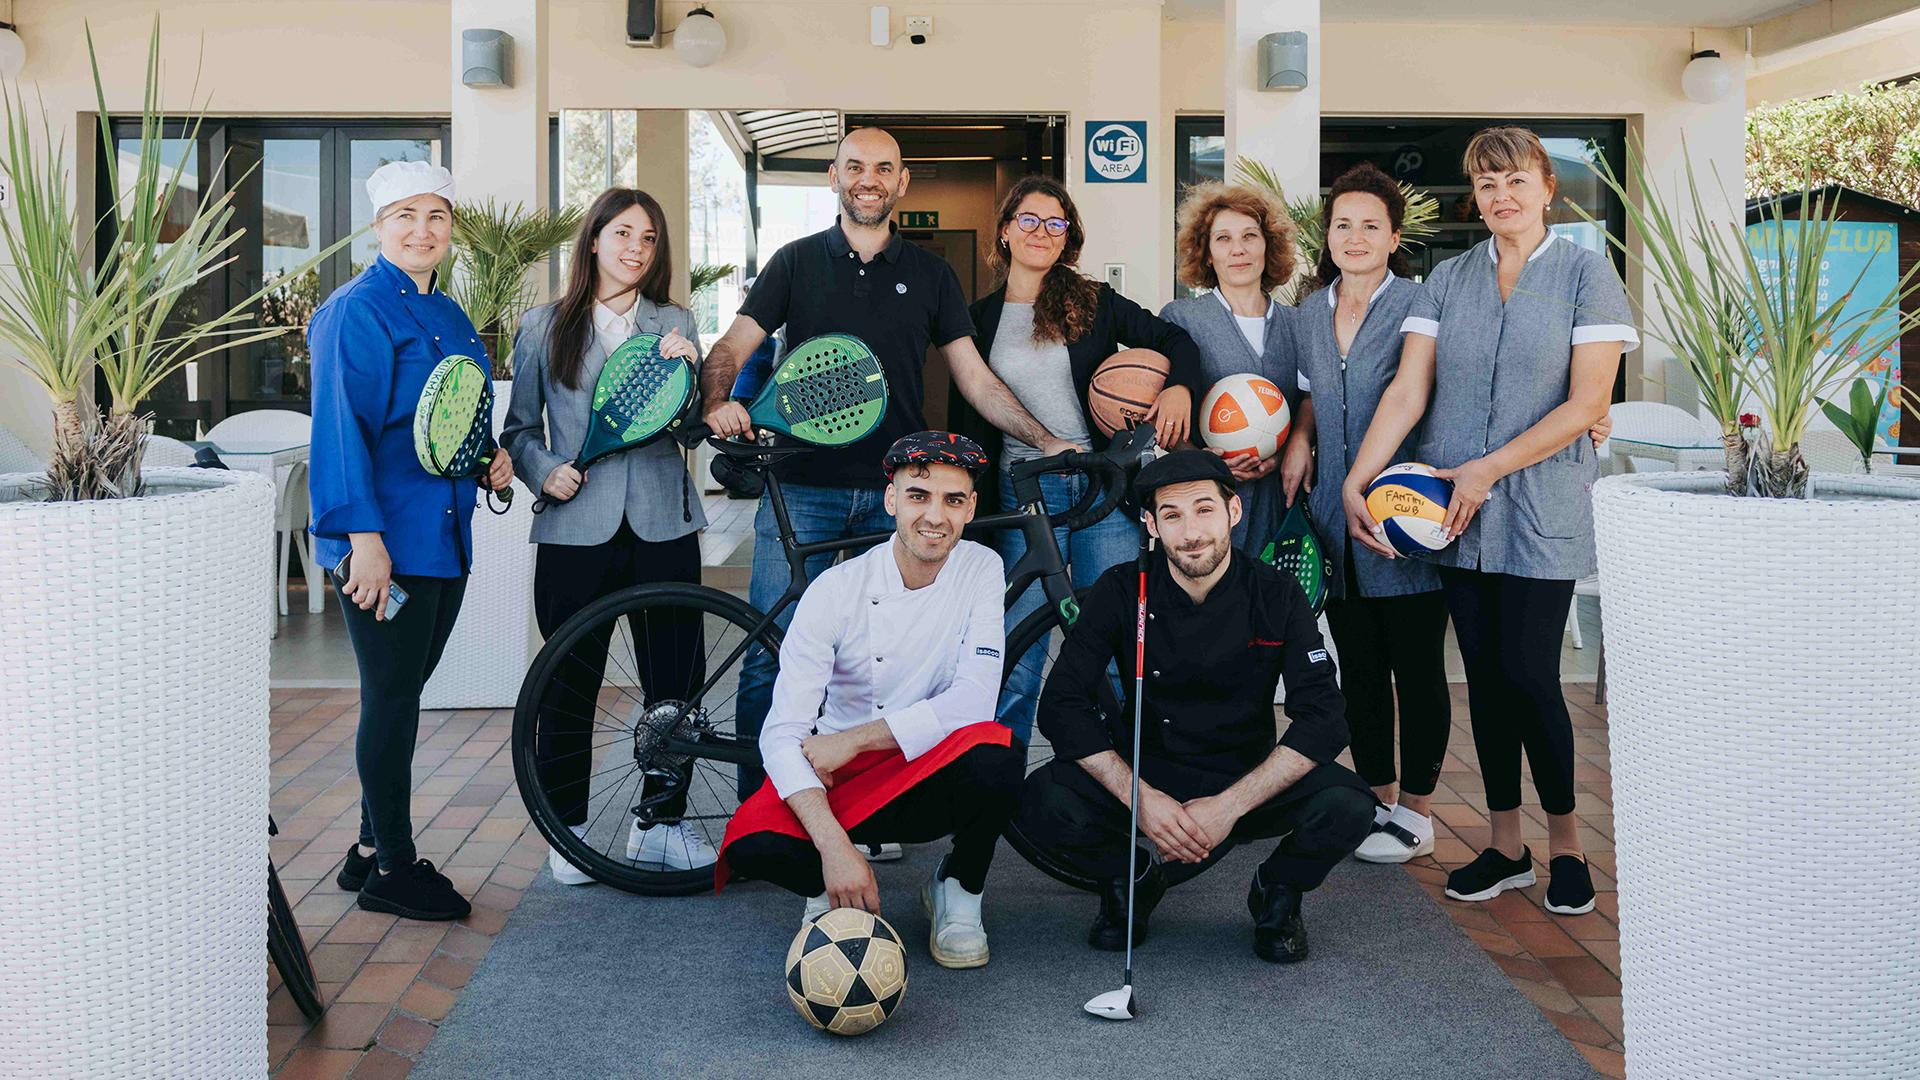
[1342,127,1640,915]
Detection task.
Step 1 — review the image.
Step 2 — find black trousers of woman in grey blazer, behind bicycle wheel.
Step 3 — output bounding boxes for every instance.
[534,519,707,824]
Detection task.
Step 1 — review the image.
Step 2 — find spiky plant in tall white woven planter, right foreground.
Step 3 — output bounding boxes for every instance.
[1594,136,1920,1078]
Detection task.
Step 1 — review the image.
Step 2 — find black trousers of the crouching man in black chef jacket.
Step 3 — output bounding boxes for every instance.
[1014,757,1375,892]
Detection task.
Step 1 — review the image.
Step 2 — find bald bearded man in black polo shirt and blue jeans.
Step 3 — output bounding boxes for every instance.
[701,127,1073,798]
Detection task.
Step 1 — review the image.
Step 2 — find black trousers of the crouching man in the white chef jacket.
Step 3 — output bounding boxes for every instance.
[726,746,1029,896]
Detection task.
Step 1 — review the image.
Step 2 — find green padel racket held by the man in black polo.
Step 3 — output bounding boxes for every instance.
[689,334,887,446]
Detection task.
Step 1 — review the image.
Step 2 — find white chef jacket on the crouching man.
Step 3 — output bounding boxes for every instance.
[760,538,1006,799]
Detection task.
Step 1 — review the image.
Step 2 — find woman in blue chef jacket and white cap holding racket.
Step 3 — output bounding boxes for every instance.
[307,161,513,919]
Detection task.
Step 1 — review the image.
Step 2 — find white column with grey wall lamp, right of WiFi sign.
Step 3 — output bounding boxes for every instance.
[1223,0,1323,198]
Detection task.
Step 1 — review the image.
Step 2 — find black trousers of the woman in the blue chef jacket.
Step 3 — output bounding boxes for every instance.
[334,575,467,871]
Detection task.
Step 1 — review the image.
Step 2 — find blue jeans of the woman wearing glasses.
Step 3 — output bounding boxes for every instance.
[998,469,1140,746]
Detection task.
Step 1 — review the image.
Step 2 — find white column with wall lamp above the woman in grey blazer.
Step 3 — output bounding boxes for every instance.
[447,0,547,209]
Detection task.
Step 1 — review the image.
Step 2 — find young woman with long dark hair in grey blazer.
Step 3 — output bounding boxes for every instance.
[501,188,714,884]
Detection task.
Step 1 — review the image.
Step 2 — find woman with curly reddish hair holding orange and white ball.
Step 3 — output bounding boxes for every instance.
[1160,183,1311,555]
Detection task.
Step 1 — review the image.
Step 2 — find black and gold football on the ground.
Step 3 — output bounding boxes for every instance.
[787,907,906,1036]
